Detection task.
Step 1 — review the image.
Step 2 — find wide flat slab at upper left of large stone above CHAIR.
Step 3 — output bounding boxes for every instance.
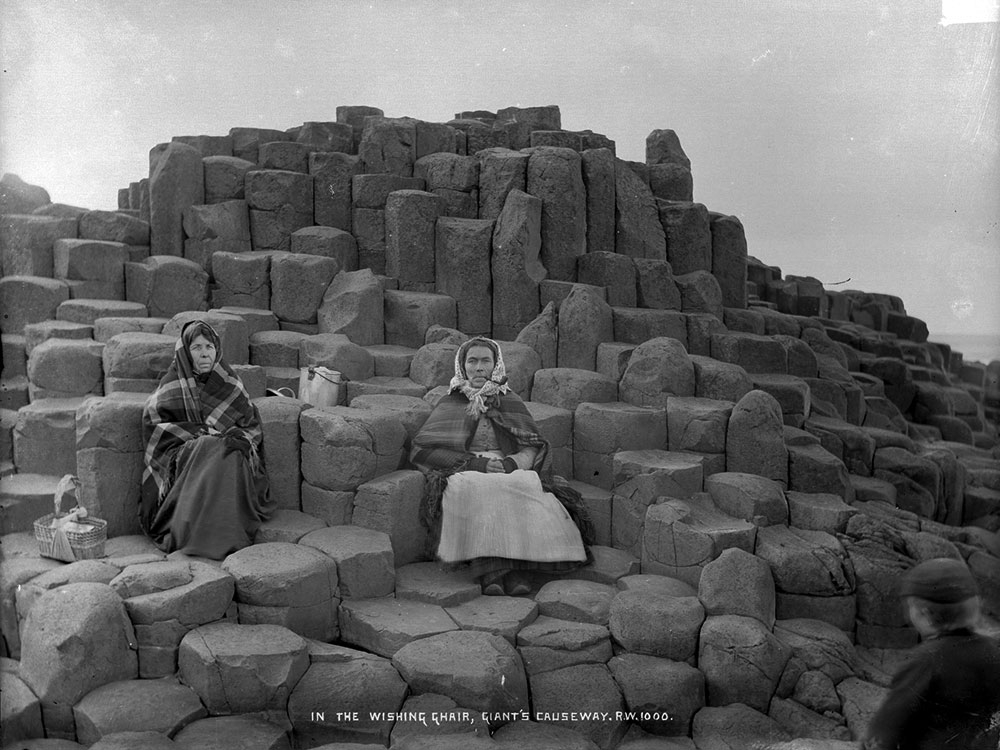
[340,597,458,657]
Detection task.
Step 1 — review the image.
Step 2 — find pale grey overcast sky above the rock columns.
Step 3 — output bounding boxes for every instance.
[0,0,1000,340]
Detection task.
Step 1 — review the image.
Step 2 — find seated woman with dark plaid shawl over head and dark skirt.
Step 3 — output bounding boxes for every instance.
[139,321,273,560]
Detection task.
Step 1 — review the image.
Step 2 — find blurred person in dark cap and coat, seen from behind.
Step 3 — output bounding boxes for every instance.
[861,558,1000,750]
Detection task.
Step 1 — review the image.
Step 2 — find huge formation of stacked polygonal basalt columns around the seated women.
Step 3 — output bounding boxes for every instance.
[0,106,1000,750]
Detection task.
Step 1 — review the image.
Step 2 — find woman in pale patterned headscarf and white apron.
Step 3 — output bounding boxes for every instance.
[410,338,590,595]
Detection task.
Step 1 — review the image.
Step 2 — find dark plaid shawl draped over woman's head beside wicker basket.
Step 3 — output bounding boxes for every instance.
[142,320,263,501]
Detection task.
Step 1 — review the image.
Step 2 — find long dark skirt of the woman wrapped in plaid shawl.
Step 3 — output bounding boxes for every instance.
[149,435,273,560]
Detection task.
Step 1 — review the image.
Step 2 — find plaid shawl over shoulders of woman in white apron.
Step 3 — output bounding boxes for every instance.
[410,391,549,474]
